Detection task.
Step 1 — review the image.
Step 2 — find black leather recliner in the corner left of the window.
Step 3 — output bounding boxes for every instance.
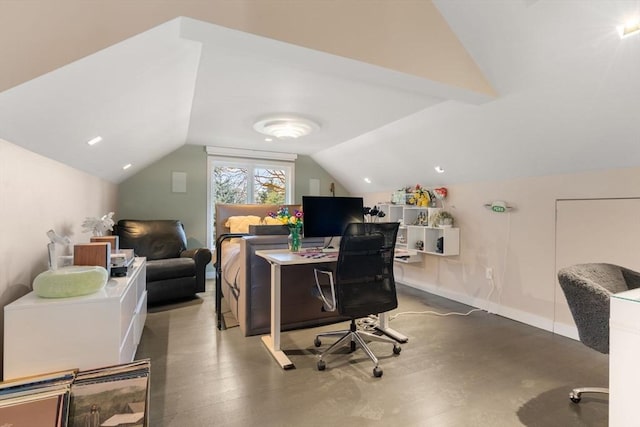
[114,219,211,305]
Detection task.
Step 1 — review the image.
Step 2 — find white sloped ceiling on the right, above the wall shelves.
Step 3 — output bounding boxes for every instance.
[314,0,640,193]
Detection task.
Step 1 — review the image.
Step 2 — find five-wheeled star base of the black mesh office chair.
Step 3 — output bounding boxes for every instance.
[313,320,402,377]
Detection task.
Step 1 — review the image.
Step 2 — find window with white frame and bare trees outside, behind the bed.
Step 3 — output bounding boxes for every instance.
[207,147,296,248]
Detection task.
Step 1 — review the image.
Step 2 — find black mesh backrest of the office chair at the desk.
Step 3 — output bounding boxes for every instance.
[335,232,398,318]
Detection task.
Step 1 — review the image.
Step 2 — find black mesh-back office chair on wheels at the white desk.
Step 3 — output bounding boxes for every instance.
[314,223,401,377]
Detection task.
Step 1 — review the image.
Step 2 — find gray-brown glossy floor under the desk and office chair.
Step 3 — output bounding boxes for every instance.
[137,283,608,427]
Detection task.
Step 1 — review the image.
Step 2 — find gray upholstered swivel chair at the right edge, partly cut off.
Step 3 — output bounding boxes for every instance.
[558,263,640,403]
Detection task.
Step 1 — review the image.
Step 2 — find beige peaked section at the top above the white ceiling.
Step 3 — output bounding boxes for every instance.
[0,0,495,96]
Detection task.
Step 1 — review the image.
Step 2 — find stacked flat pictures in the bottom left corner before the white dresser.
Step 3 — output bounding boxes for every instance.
[0,359,151,427]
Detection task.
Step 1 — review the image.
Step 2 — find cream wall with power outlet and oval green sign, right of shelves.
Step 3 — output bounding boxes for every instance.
[365,168,640,336]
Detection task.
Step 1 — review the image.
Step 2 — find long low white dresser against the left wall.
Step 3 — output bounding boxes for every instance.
[4,258,147,380]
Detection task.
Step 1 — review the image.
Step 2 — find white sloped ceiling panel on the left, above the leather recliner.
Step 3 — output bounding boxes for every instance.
[0,19,201,182]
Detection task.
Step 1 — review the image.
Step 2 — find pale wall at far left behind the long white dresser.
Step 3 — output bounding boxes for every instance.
[0,139,116,376]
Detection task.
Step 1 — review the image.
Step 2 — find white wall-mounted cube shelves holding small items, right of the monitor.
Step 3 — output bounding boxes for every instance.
[378,204,460,256]
